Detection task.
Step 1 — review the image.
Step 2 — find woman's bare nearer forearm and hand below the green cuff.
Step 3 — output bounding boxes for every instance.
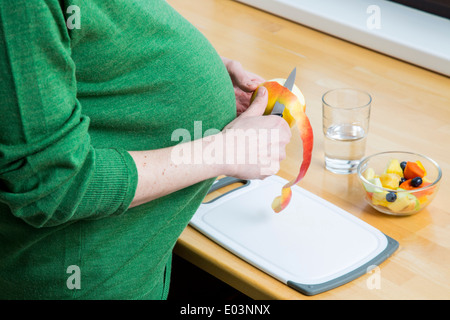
[129,87,291,207]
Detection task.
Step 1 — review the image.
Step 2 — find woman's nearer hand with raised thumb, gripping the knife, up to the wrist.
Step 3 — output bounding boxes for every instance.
[220,87,291,179]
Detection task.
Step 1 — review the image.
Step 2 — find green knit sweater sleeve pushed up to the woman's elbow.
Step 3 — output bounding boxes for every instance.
[0,0,137,228]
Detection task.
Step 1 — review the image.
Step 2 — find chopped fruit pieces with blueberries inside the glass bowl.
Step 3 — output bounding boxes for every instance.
[362,159,435,214]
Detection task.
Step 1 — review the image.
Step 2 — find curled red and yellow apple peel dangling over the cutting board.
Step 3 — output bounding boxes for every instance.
[251,79,314,213]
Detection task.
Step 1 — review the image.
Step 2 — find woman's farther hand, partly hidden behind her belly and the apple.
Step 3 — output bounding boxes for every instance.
[222,57,265,115]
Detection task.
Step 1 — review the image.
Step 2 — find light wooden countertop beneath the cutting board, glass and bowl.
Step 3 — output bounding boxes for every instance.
[168,0,450,299]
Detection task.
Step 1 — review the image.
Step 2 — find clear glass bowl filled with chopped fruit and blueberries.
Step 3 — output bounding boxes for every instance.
[357,151,442,216]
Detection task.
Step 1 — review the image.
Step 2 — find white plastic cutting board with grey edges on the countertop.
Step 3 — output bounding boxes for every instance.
[190,176,398,295]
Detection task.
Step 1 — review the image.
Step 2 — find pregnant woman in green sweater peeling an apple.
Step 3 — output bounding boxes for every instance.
[0,0,290,299]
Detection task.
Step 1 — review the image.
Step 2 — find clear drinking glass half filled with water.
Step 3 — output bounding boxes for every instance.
[322,89,372,174]
